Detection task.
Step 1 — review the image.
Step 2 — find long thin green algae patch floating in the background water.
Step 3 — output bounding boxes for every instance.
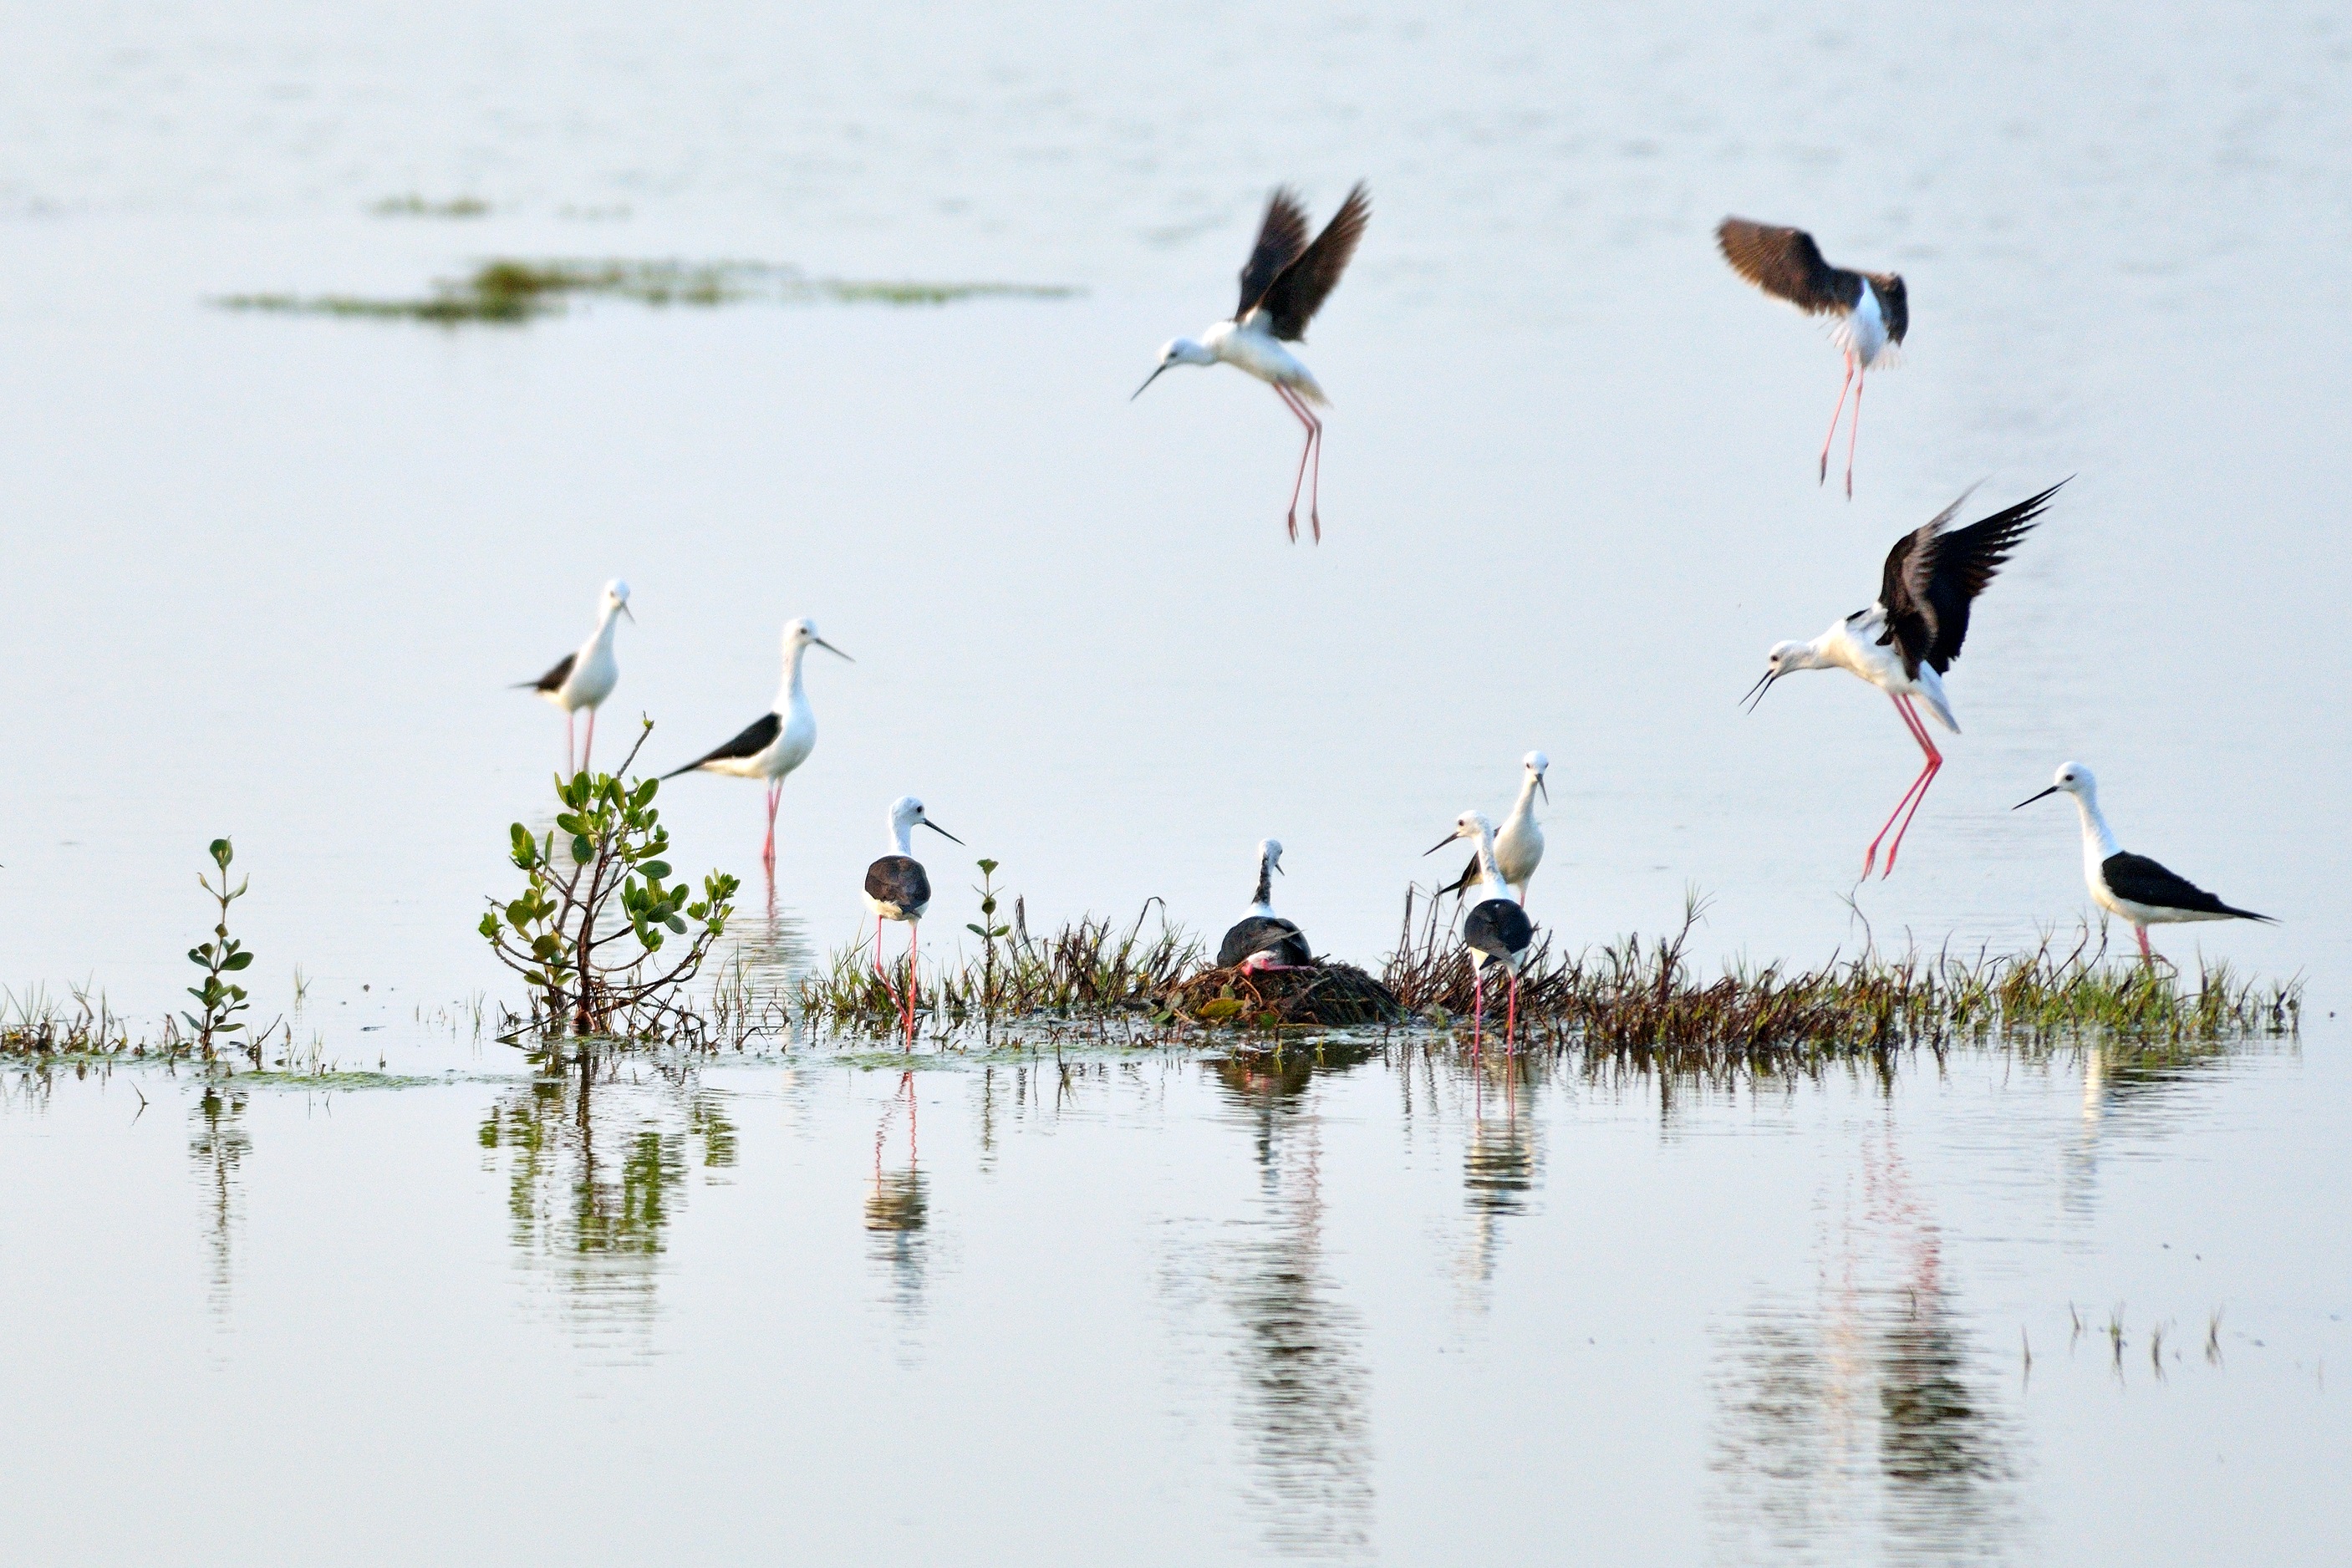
[211,258,1080,327]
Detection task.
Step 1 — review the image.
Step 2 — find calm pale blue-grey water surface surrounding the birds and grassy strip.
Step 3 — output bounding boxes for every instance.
[0,3,2352,1563]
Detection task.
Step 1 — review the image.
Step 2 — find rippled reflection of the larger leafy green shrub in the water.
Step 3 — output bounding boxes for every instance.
[477,1051,736,1311]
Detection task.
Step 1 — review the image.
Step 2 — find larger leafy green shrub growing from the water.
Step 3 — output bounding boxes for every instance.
[477,720,739,1035]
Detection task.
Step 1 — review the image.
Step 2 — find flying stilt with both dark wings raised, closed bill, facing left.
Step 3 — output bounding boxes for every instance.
[1127,181,1372,543]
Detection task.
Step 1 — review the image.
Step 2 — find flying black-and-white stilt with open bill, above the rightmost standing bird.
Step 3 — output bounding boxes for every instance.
[1743,480,2065,877]
